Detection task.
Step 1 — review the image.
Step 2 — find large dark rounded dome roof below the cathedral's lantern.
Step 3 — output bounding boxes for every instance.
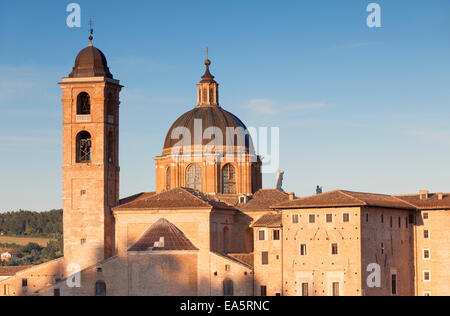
[164,106,250,150]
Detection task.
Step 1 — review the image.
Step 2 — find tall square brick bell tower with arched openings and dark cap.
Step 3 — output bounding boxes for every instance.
[59,31,122,269]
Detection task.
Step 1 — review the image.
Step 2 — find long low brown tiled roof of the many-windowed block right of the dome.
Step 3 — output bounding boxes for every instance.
[273,190,415,210]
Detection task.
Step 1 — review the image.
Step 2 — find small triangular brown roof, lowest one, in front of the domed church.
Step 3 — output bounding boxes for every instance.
[128,218,198,251]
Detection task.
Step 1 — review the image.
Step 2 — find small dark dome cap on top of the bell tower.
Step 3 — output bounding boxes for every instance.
[69,43,113,78]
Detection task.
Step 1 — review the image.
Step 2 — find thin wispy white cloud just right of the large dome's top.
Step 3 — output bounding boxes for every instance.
[245,99,327,115]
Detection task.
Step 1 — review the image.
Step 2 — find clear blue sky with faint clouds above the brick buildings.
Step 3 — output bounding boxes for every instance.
[0,0,450,210]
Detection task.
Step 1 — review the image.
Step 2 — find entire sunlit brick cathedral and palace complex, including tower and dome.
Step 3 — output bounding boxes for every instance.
[0,37,450,296]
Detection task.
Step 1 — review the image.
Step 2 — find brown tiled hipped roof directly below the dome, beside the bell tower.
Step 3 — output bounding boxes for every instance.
[113,188,235,211]
